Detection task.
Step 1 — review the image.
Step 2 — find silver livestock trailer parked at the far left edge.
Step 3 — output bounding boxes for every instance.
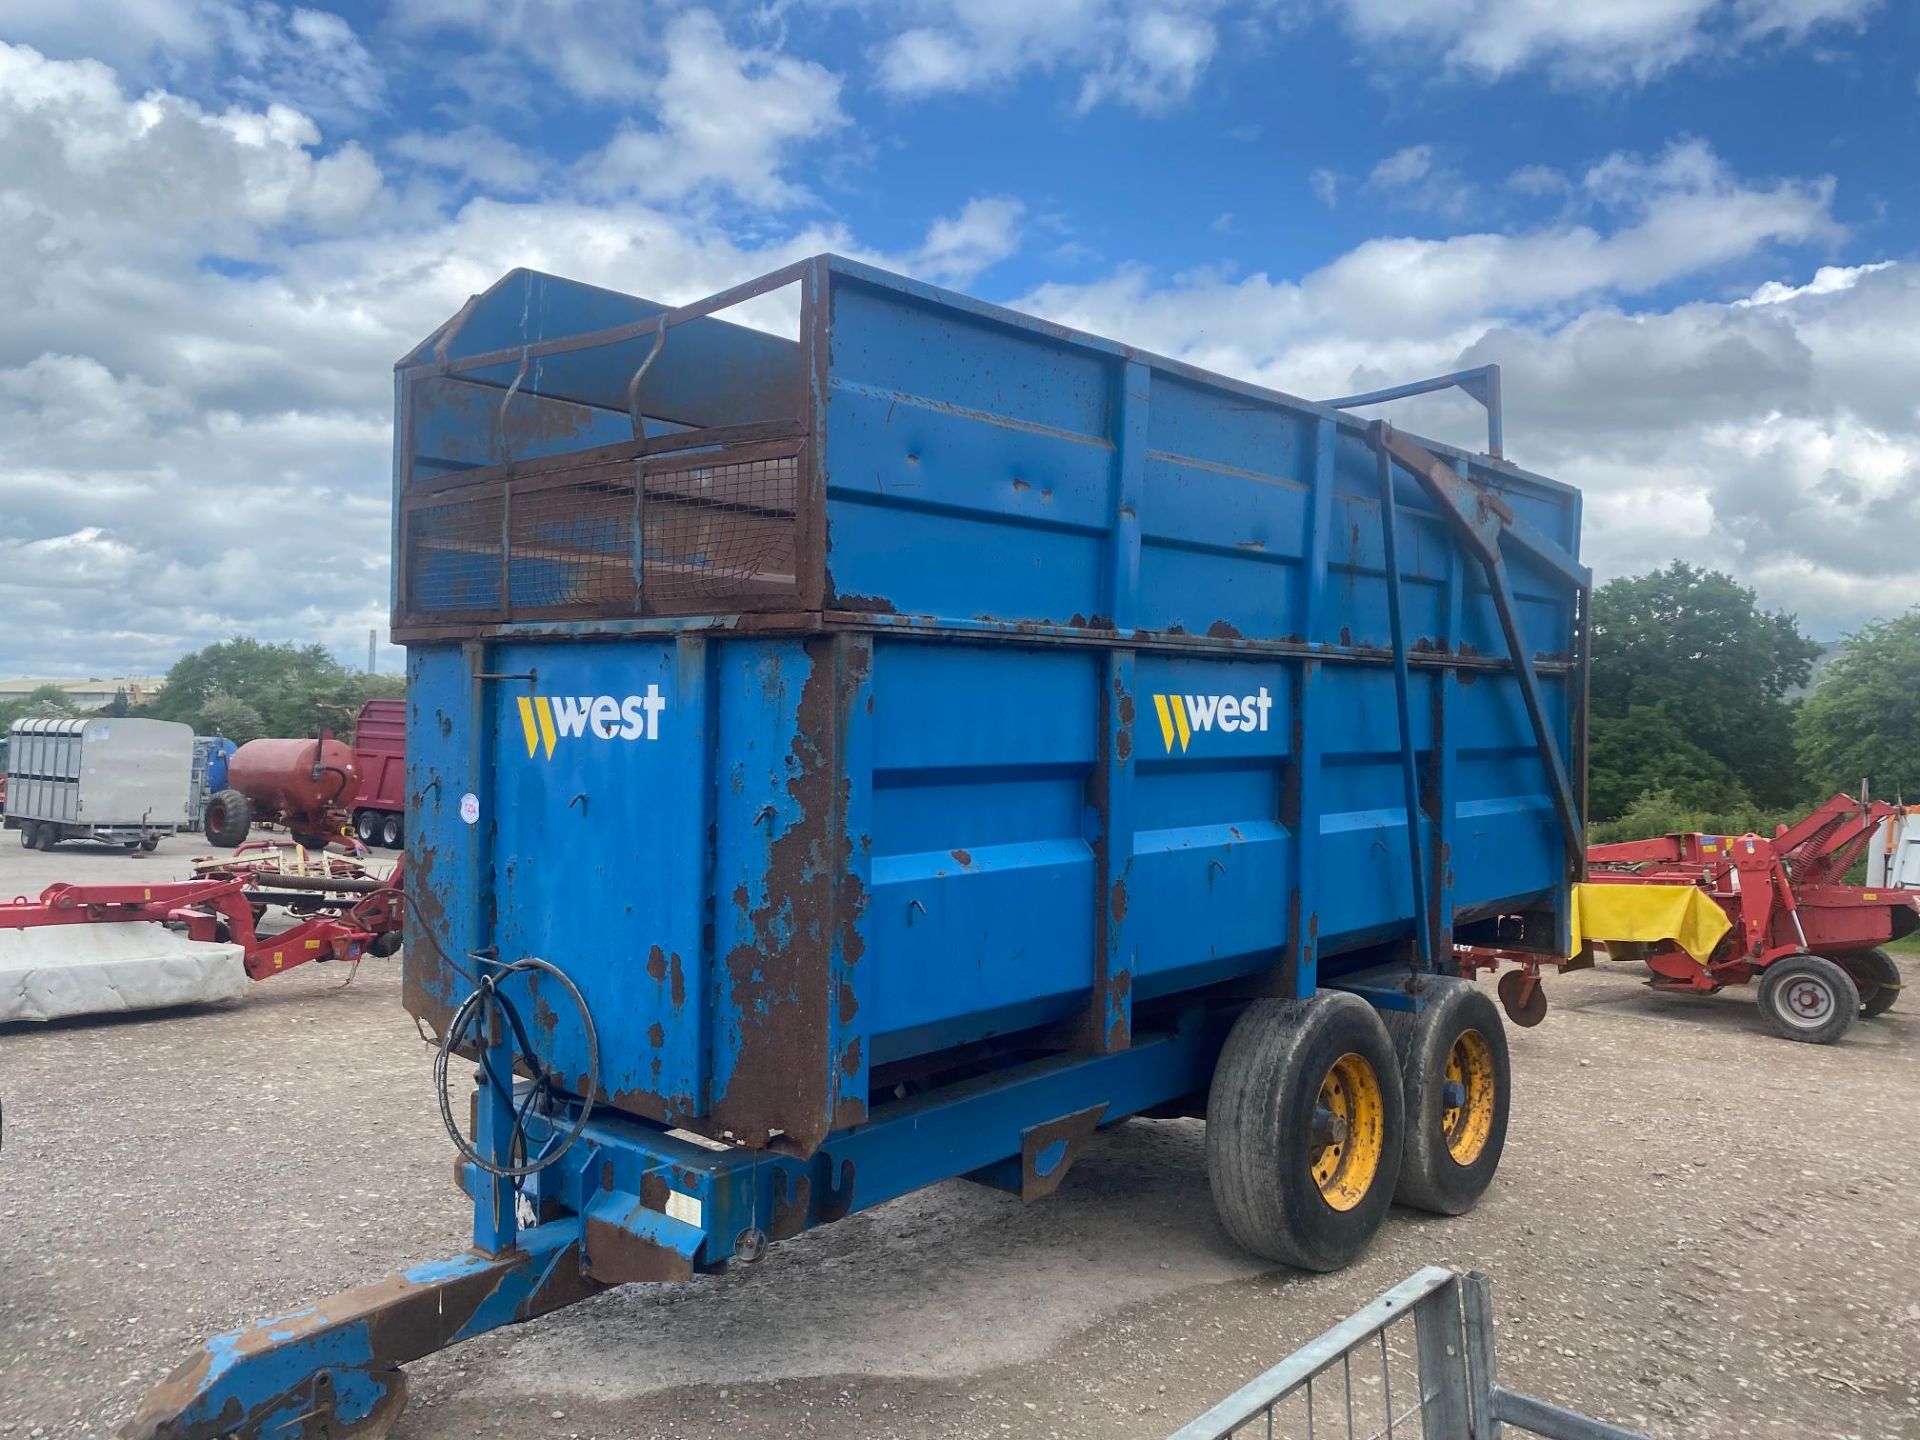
[6,716,194,851]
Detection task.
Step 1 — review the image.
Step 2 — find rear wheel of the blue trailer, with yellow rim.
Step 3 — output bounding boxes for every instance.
[1380,979,1513,1215]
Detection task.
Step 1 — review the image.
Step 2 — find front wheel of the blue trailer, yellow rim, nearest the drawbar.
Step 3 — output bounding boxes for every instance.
[1206,991,1405,1271]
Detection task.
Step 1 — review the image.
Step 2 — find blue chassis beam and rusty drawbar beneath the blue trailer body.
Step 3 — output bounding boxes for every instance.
[117,1006,1238,1440]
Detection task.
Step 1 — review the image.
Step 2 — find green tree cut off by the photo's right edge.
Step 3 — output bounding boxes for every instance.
[1795,607,1920,801]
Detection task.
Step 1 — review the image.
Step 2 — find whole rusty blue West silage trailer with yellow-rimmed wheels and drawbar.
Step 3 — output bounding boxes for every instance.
[129,257,1588,1436]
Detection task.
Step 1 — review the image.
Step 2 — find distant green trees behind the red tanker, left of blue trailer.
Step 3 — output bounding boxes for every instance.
[144,636,405,739]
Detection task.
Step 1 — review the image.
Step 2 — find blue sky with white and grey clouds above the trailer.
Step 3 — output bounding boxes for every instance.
[0,0,1920,674]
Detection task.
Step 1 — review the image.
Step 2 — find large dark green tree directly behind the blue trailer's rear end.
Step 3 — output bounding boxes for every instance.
[1588,561,1820,820]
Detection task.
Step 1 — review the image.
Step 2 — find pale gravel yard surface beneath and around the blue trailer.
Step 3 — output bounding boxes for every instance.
[0,837,1920,1440]
